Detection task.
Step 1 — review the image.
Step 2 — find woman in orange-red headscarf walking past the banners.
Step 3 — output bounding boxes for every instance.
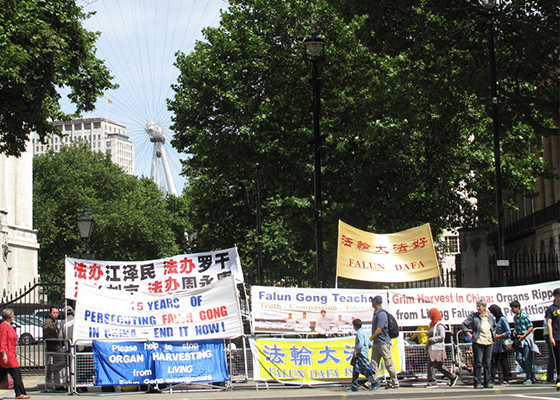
[426,308,459,388]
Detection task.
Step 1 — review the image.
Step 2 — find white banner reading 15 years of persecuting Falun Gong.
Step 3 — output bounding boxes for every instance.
[74,276,243,343]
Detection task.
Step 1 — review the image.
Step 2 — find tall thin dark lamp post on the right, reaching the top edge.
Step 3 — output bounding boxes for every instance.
[479,0,509,286]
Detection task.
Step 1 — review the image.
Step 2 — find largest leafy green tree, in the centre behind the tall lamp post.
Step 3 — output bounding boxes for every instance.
[170,0,543,285]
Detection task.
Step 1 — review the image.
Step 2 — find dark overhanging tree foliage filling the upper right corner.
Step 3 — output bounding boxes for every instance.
[328,0,560,214]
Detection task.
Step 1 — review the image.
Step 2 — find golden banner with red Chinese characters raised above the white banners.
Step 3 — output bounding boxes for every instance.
[337,220,440,282]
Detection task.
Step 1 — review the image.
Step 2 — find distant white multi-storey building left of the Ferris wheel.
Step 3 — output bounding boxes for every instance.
[32,117,134,174]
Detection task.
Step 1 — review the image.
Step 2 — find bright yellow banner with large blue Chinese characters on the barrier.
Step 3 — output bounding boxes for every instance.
[249,336,404,385]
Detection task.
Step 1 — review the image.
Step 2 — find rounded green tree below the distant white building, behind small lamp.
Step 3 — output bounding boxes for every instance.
[33,144,180,282]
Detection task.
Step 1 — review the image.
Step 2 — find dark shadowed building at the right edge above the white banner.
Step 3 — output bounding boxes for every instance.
[457,135,560,287]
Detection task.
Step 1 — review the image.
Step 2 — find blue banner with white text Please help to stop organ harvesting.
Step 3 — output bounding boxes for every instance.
[92,339,229,386]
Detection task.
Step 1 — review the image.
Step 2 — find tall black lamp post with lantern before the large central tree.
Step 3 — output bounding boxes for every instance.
[303,24,325,288]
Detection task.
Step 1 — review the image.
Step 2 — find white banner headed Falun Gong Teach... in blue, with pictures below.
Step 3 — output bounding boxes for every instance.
[251,286,385,334]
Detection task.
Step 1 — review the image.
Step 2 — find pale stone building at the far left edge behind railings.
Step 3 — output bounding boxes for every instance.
[0,148,39,298]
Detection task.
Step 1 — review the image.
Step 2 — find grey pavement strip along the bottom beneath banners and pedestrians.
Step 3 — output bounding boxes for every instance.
[0,375,560,400]
